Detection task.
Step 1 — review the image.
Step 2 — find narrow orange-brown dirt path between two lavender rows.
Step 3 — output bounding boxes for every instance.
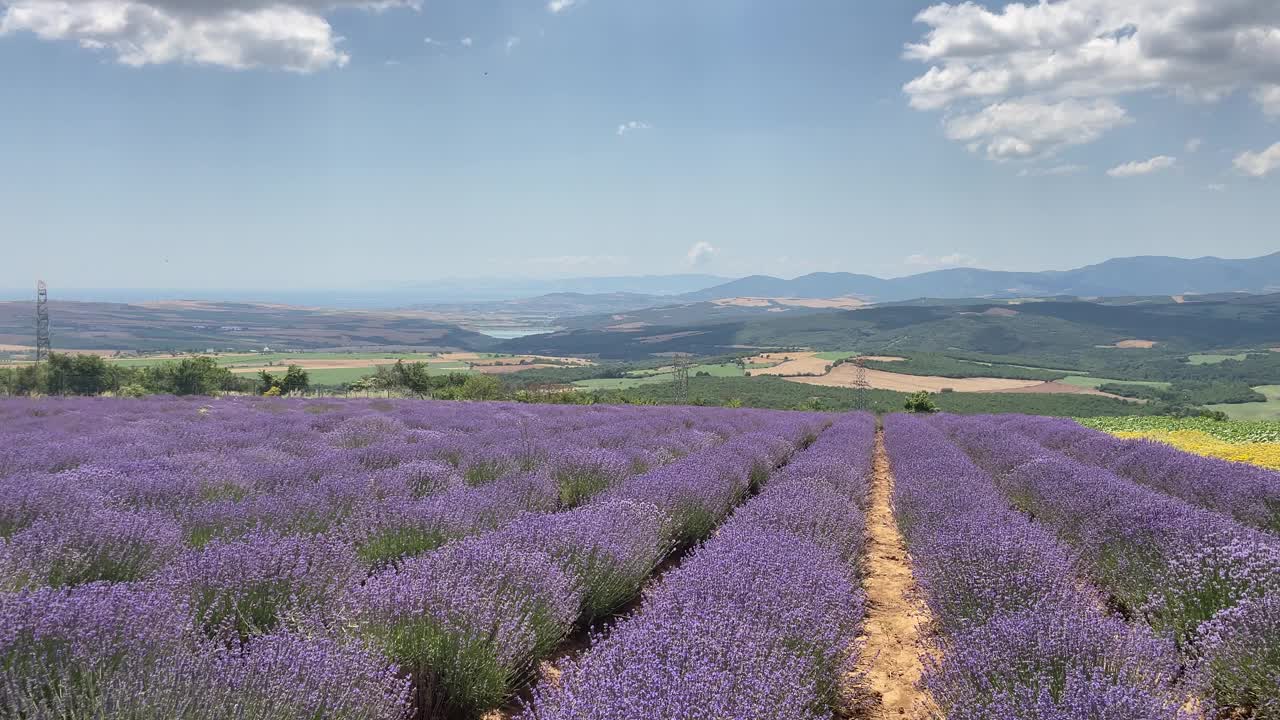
[859,430,933,720]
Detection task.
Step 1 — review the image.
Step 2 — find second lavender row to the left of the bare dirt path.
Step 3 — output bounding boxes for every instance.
[344,425,815,716]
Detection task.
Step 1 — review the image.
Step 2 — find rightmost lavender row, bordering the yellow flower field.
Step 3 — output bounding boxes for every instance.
[991,415,1280,533]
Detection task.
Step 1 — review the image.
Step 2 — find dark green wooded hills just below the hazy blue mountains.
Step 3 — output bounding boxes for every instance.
[502,293,1280,359]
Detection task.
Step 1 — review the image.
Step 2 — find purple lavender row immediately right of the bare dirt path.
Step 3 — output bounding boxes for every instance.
[884,415,1181,720]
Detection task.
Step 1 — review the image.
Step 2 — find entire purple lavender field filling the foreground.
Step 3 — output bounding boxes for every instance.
[0,398,1280,720]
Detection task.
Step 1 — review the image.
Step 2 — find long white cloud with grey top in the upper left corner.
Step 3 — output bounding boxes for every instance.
[0,0,420,73]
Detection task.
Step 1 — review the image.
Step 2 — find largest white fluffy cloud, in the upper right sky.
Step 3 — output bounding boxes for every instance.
[904,0,1280,158]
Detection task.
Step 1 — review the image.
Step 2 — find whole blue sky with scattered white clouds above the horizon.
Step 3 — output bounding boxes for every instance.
[0,0,1280,288]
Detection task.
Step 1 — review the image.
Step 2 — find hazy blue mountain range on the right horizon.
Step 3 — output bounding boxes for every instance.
[681,252,1280,302]
